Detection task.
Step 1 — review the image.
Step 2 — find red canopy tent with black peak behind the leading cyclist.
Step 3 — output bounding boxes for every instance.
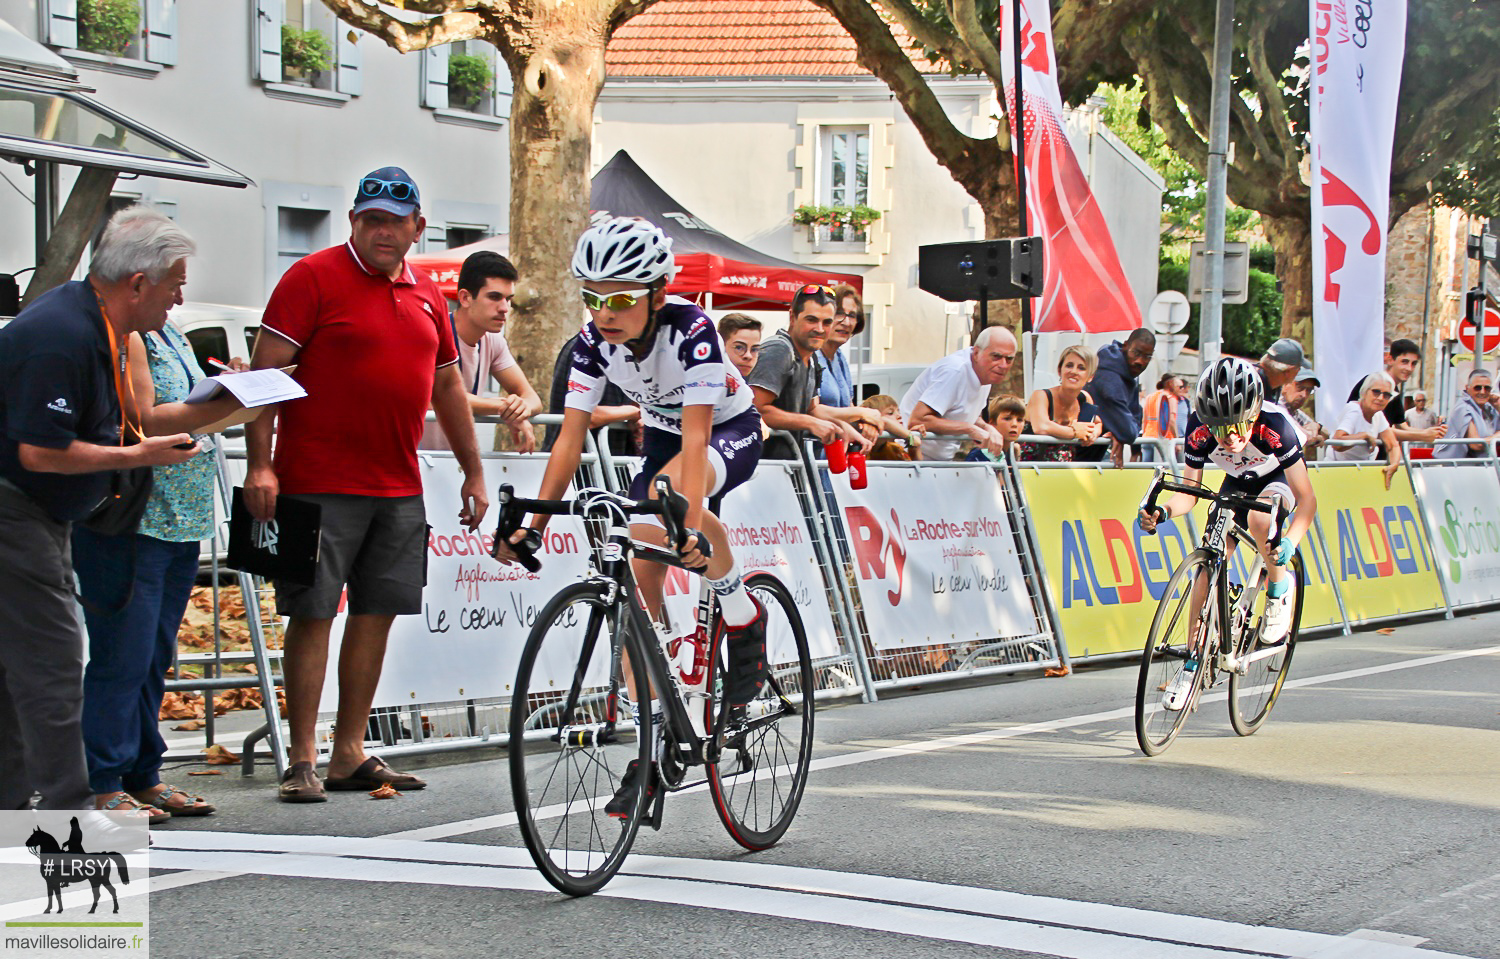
[407,150,863,309]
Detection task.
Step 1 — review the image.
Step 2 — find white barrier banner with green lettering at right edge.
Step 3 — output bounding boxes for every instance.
[1412,464,1500,606]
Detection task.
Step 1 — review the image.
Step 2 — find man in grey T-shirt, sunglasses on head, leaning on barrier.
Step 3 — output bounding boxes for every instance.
[747,285,867,459]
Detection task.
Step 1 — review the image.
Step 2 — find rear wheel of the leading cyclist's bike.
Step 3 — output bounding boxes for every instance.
[707,572,815,851]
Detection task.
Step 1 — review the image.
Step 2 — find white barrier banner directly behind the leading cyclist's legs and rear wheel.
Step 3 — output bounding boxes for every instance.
[666,462,840,663]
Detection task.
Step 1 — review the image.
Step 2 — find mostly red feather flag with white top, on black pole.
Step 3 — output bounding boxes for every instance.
[1001,0,1142,333]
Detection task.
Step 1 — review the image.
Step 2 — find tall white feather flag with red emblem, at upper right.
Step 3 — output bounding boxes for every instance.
[1310,0,1407,422]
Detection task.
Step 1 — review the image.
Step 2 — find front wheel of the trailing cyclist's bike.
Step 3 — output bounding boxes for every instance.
[1136,549,1217,756]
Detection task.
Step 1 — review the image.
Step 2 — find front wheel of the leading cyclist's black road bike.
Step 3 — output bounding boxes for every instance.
[510,582,651,896]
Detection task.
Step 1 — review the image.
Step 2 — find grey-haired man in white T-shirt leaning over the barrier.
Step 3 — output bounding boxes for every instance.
[902,326,1016,459]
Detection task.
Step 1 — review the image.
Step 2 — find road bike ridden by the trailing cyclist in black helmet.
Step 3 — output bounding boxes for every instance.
[1136,473,1304,756]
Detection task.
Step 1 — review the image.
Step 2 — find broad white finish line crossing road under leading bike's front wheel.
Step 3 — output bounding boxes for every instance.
[152,831,1461,959]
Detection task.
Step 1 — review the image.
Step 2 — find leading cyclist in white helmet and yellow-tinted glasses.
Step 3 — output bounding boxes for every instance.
[495,216,765,818]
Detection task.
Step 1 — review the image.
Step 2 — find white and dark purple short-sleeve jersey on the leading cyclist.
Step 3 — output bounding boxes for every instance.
[564,297,755,434]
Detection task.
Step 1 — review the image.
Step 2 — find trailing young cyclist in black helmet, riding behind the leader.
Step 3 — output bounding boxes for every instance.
[1137,356,1317,645]
